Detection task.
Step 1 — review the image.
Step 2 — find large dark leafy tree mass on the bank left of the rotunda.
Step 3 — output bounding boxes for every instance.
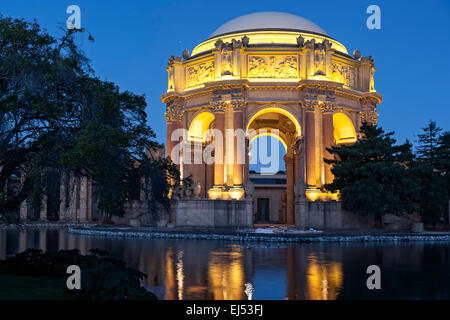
[0,16,178,217]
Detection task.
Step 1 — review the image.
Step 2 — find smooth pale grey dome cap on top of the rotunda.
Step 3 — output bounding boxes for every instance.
[210,12,328,38]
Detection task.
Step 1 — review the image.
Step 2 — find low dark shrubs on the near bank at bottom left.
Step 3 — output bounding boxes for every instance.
[0,249,156,300]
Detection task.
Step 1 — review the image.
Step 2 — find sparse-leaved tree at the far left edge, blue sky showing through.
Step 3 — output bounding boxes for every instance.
[0,16,89,214]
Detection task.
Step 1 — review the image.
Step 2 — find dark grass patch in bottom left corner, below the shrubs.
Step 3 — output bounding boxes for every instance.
[0,274,70,300]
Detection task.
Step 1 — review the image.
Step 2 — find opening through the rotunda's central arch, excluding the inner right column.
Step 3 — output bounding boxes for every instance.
[247,107,301,224]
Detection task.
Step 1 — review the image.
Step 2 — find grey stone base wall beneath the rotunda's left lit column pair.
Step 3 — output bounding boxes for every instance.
[173,199,253,228]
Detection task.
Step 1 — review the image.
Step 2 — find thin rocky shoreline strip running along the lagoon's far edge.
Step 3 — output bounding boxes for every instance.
[0,222,450,243]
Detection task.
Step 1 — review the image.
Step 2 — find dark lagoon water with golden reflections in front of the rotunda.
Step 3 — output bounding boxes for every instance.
[0,229,450,300]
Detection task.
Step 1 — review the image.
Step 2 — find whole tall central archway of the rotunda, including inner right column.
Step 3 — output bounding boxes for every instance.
[247,107,301,224]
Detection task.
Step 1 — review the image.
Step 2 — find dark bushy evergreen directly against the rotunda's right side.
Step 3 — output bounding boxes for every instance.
[325,123,418,223]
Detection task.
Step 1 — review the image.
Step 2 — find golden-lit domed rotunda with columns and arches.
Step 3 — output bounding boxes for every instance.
[162,12,382,227]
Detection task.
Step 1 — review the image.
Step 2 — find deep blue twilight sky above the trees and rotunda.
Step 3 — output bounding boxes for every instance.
[0,0,450,149]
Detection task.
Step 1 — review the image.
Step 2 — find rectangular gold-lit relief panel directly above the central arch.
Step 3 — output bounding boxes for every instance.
[248,56,298,78]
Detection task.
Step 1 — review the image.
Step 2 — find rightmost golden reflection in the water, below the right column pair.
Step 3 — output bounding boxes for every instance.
[306,256,343,300]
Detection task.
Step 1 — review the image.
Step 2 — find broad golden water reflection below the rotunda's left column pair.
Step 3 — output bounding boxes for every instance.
[208,246,245,300]
